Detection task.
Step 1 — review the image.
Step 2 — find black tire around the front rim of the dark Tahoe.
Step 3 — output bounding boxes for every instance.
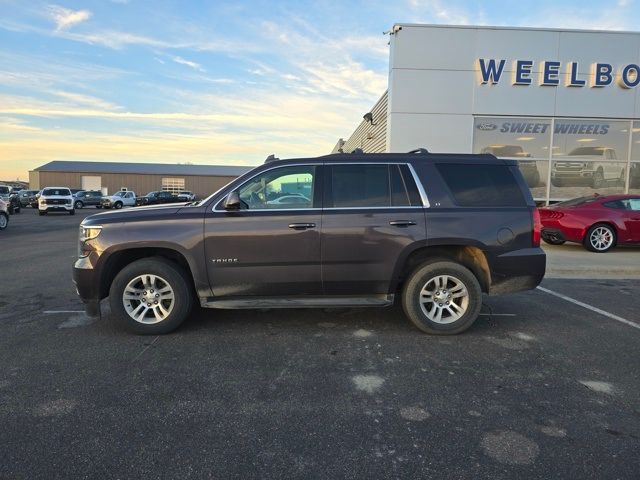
[109,257,194,335]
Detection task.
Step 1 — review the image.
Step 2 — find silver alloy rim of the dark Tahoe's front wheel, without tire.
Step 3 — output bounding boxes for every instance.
[122,274,175,324]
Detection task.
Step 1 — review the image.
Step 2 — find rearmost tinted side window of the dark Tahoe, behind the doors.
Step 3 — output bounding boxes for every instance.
[436,163,526,207]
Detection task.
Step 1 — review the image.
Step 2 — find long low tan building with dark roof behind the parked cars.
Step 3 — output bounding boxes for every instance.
[29,160,252,198]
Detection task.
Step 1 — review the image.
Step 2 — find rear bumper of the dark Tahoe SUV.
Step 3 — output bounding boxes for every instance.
[489,248,547,295]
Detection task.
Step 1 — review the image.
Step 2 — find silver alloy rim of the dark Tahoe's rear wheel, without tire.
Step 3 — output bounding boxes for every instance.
[420,275,469,324]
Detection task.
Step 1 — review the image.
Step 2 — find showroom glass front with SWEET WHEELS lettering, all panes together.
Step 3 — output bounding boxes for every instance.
[473,117,640,202]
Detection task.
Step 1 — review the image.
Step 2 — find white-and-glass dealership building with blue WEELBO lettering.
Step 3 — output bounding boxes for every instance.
[333,24,640,202]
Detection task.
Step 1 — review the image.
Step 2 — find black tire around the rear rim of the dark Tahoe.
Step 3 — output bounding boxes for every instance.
[402,260,482,335]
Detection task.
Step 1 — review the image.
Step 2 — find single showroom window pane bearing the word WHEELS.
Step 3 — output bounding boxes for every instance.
[550,119,630,199]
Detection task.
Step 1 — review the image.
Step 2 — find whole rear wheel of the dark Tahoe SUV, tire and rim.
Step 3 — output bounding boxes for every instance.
[402,260,482,335]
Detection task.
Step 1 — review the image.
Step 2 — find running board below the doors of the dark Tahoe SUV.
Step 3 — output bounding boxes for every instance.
[200,295,393,310]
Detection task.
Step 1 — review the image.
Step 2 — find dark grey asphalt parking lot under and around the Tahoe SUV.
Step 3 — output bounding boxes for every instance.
[0,208,640,479]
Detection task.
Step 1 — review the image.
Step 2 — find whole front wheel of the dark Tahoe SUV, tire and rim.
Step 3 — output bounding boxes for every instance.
[109,257,193,335]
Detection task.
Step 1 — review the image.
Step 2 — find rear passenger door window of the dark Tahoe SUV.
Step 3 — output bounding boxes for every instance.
[325,164,415,208]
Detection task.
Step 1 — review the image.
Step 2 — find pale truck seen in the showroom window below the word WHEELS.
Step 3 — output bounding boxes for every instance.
[551,146,625,188]
